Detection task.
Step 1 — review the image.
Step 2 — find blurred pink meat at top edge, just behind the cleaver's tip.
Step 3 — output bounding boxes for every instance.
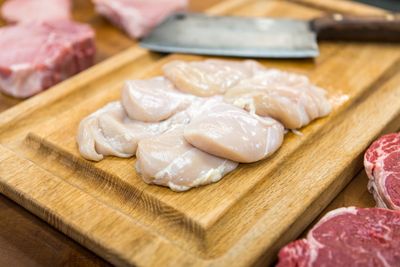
[93,0,188,38]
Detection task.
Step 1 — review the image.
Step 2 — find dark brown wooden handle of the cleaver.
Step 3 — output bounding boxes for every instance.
[311,14,400,42]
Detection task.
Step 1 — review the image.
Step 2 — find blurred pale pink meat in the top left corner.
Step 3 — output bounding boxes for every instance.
[1,0,71,23]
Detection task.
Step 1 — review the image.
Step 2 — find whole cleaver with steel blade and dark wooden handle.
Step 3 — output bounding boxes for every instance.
[140,13,400,58]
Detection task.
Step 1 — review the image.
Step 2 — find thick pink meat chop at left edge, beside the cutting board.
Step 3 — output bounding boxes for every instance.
[0,21,96,98]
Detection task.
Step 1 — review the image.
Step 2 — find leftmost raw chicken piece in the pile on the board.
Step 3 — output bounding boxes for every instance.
[77,102,189,161]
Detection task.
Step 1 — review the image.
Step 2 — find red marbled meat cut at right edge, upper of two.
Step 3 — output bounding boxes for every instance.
[364,133,400,210]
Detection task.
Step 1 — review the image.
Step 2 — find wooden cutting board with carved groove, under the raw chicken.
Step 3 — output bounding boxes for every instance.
[0,0,400,266]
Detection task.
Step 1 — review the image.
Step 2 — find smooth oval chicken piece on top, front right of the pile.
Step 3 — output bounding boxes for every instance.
[184,99,284,163]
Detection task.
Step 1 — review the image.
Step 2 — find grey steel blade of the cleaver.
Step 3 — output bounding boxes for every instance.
[140,13,319,58]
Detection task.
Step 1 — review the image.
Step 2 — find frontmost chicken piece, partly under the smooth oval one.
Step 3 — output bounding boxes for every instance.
[136,126,238,191]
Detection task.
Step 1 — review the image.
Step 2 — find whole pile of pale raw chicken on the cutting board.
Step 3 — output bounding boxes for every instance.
[77,60,331,191]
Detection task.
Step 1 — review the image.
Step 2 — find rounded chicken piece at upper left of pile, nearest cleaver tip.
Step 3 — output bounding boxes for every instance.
[122,77,193,122]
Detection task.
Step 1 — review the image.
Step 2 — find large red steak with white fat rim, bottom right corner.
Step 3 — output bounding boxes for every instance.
[277,208,400,267]
